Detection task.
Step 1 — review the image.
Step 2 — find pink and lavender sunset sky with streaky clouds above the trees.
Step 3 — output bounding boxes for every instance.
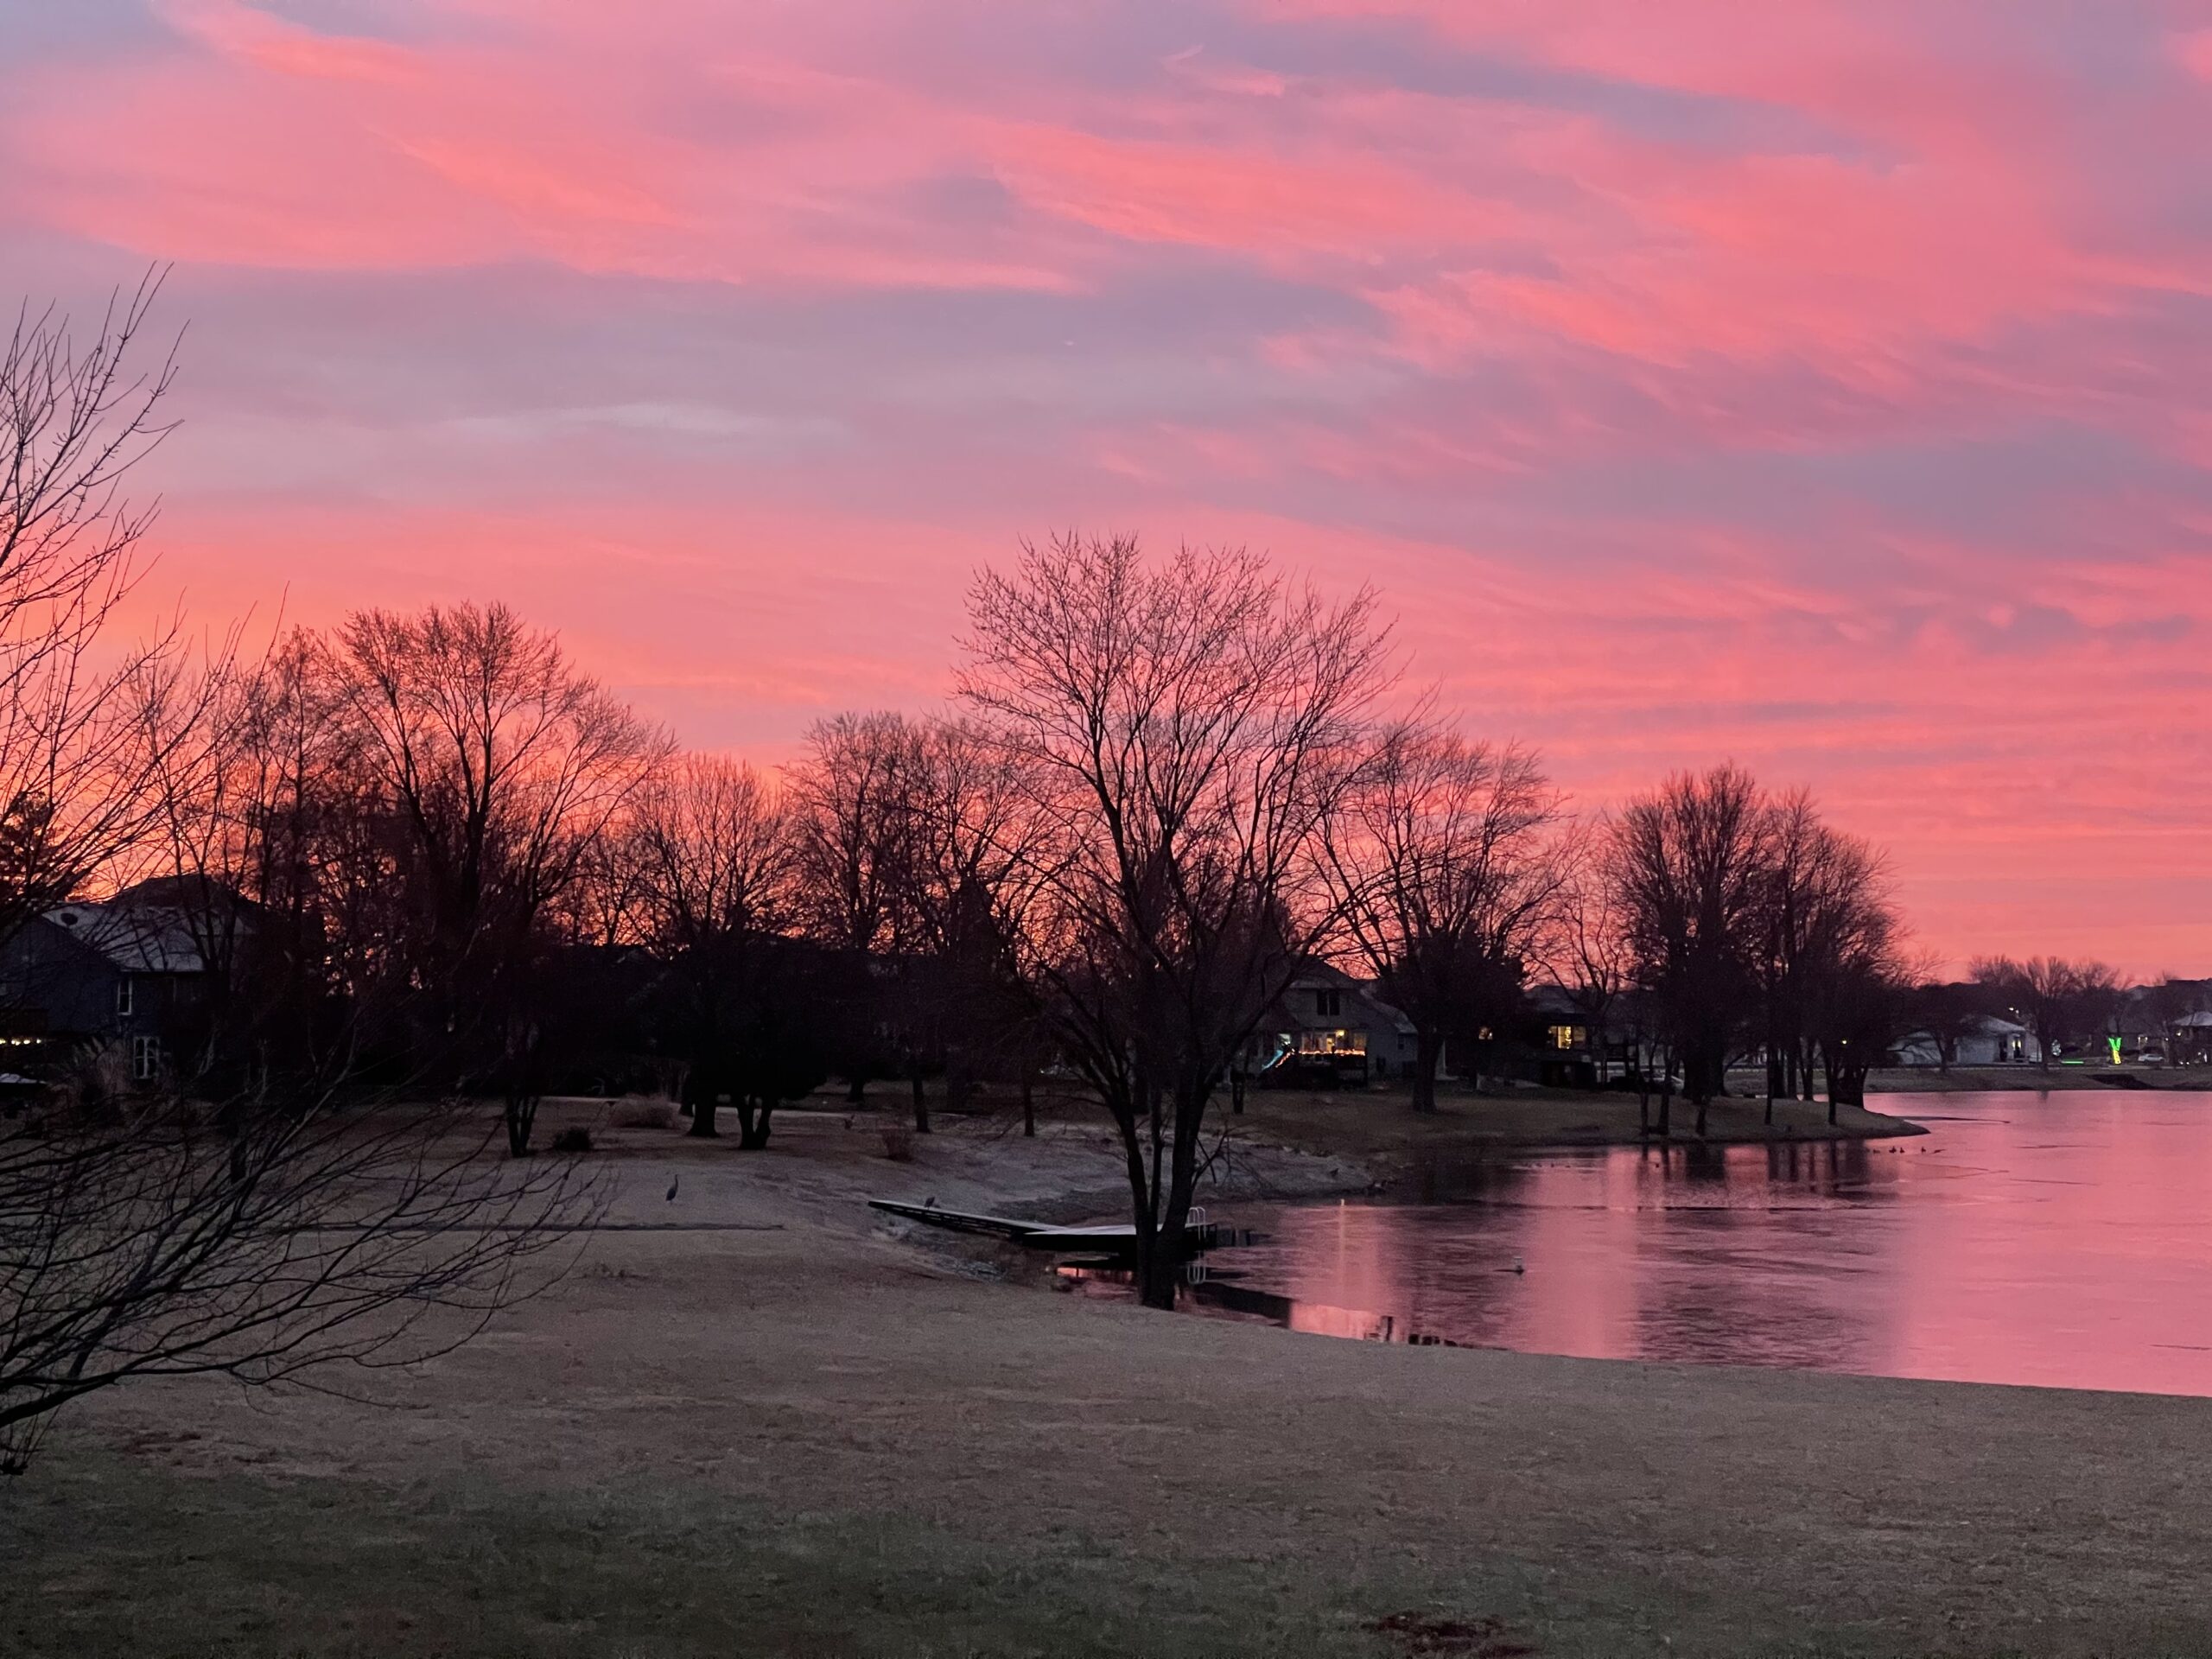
[0,0,2212,973]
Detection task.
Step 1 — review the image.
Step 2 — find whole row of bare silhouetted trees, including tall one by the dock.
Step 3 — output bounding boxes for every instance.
[118,536,1937,1296]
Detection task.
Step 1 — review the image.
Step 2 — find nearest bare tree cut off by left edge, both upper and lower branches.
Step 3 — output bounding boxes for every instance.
[0,281,595,1473]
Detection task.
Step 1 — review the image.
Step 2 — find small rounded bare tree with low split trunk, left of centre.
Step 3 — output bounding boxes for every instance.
[637,754,797,1150]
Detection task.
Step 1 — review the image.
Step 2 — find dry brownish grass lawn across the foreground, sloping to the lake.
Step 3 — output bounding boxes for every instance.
[0,1115,2212,1659]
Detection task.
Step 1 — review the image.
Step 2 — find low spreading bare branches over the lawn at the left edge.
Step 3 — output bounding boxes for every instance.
[0,1093,600,1473]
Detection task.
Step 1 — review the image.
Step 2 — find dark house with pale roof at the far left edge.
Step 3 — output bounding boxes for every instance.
[0,882,245,1082]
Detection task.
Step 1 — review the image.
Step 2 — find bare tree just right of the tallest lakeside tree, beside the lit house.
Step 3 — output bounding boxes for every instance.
[1320,723,1564,1113]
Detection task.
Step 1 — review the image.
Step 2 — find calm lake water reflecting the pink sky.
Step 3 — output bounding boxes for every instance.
[1192,1090,2212,1395]
